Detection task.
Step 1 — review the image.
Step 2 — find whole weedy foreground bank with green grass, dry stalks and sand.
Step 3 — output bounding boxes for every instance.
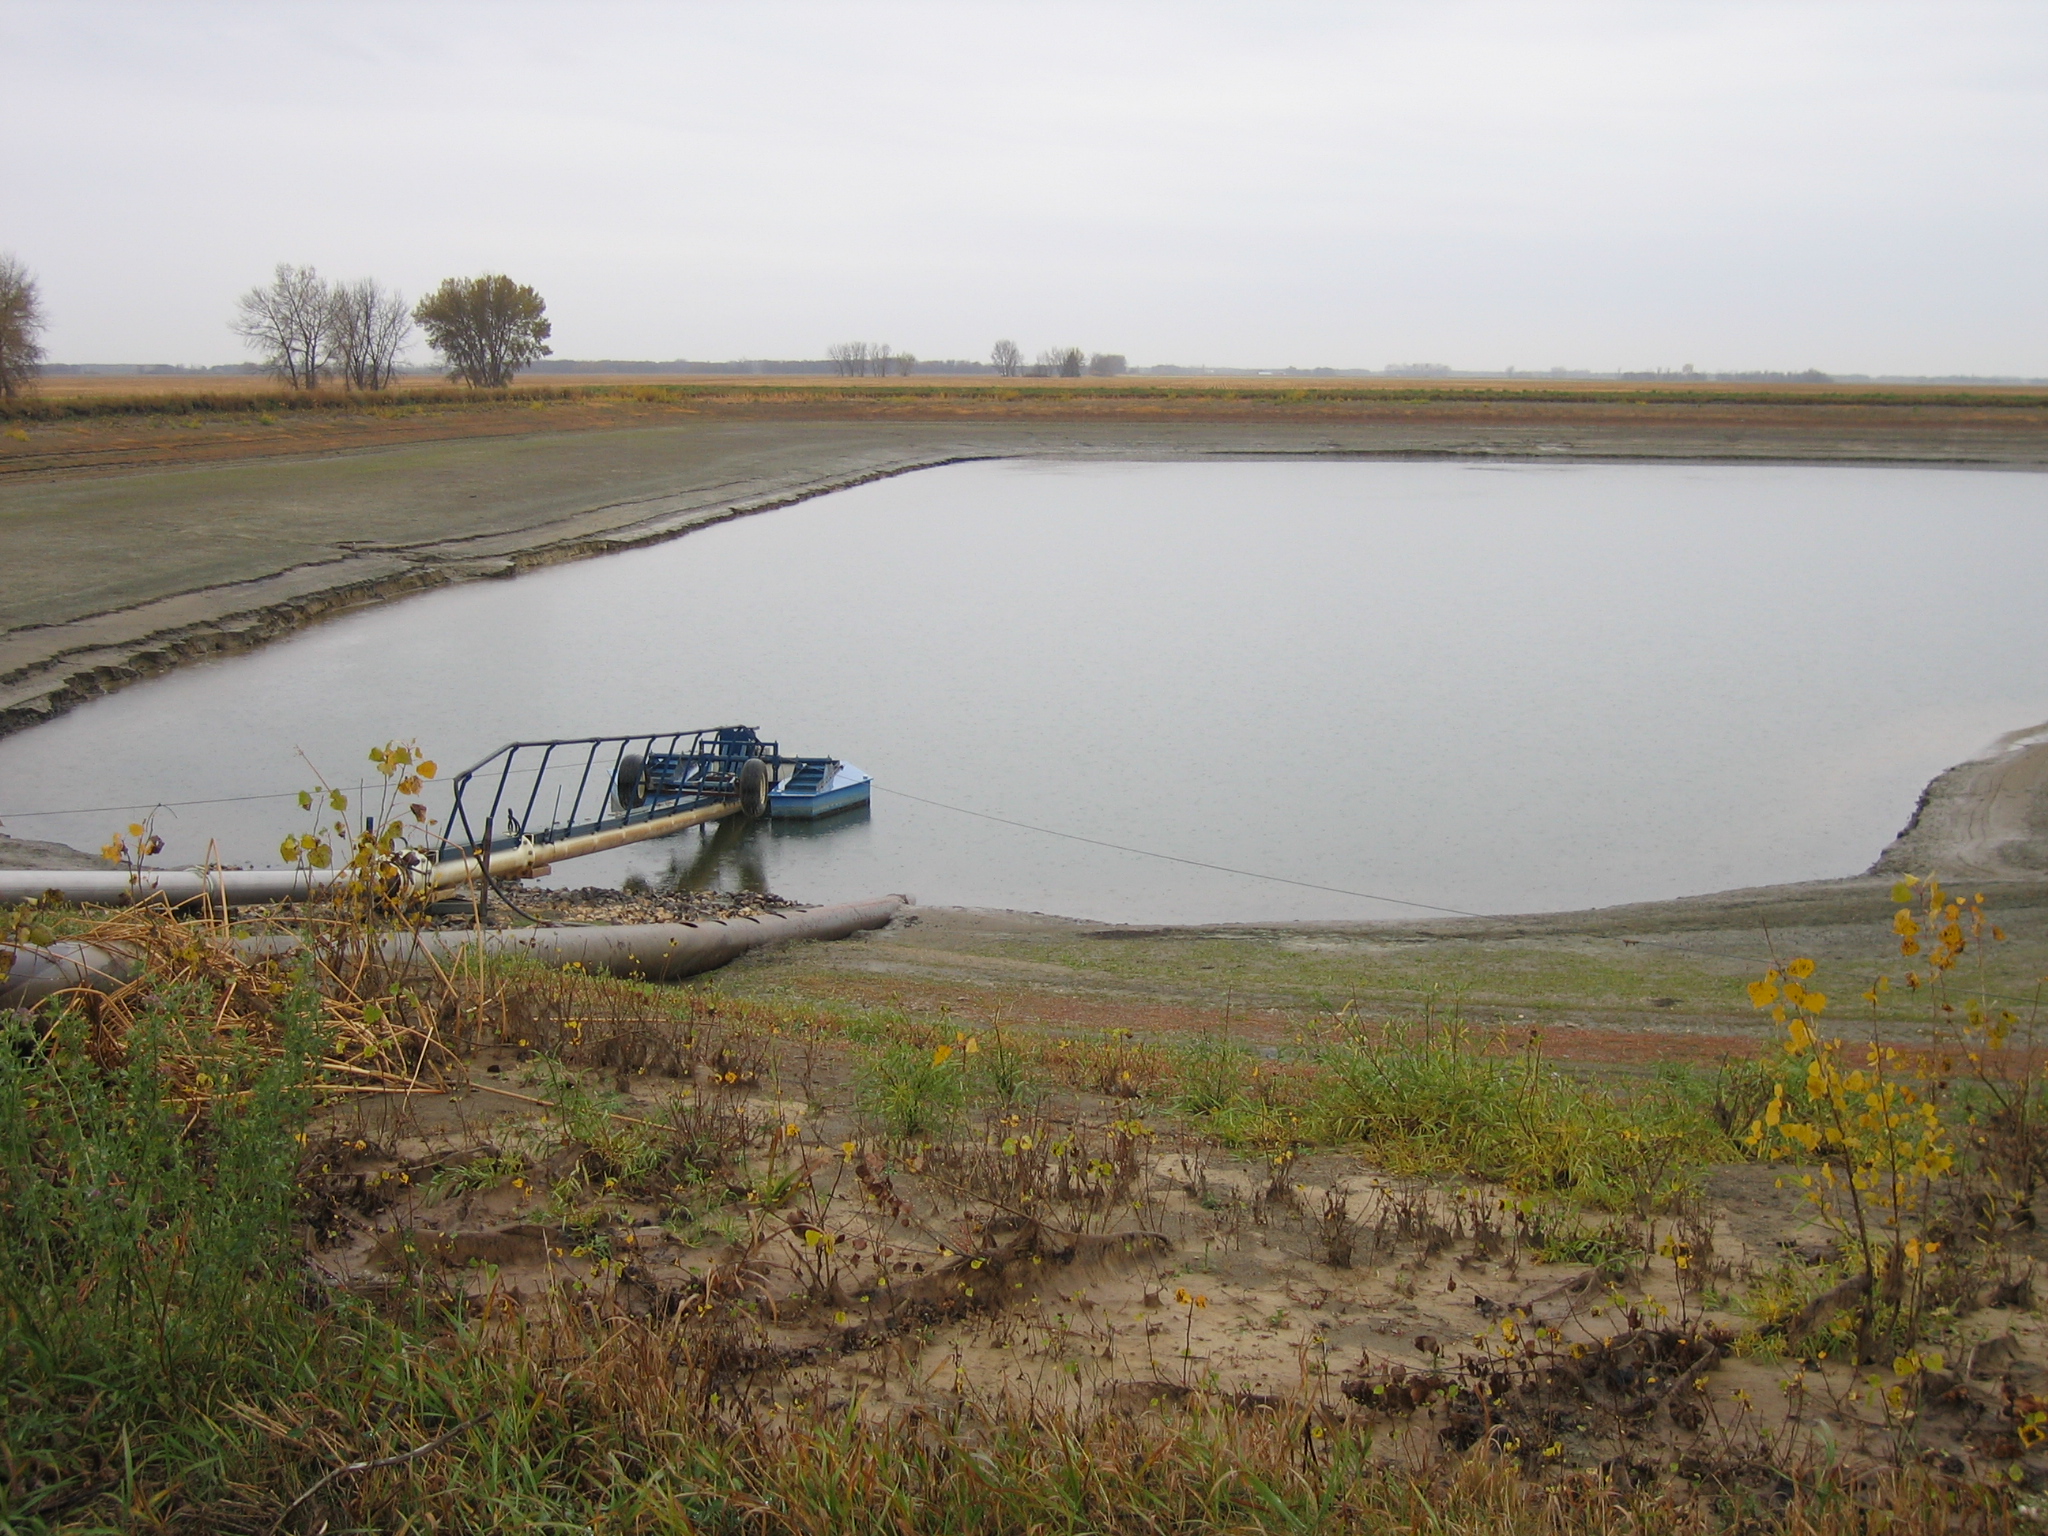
[0,872,2048,1532]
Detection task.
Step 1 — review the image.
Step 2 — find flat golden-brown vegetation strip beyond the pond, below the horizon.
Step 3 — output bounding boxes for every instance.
[0,375,2048,477]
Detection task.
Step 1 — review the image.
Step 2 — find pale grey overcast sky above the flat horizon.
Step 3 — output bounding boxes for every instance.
[0,0,2048,375]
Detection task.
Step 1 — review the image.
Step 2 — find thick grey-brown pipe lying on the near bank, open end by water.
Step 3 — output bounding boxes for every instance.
[0,897,909,1008]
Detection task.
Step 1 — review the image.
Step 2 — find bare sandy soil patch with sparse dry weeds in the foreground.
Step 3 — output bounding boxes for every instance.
[292,999,2048,1487]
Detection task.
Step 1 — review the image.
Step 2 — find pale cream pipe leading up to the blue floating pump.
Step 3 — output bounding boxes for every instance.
[0,801,739,907]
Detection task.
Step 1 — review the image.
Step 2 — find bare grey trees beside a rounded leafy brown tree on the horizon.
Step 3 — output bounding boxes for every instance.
[231,262,553,389]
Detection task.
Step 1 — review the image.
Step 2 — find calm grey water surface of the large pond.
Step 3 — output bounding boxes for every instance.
[0,463,2048,922]
